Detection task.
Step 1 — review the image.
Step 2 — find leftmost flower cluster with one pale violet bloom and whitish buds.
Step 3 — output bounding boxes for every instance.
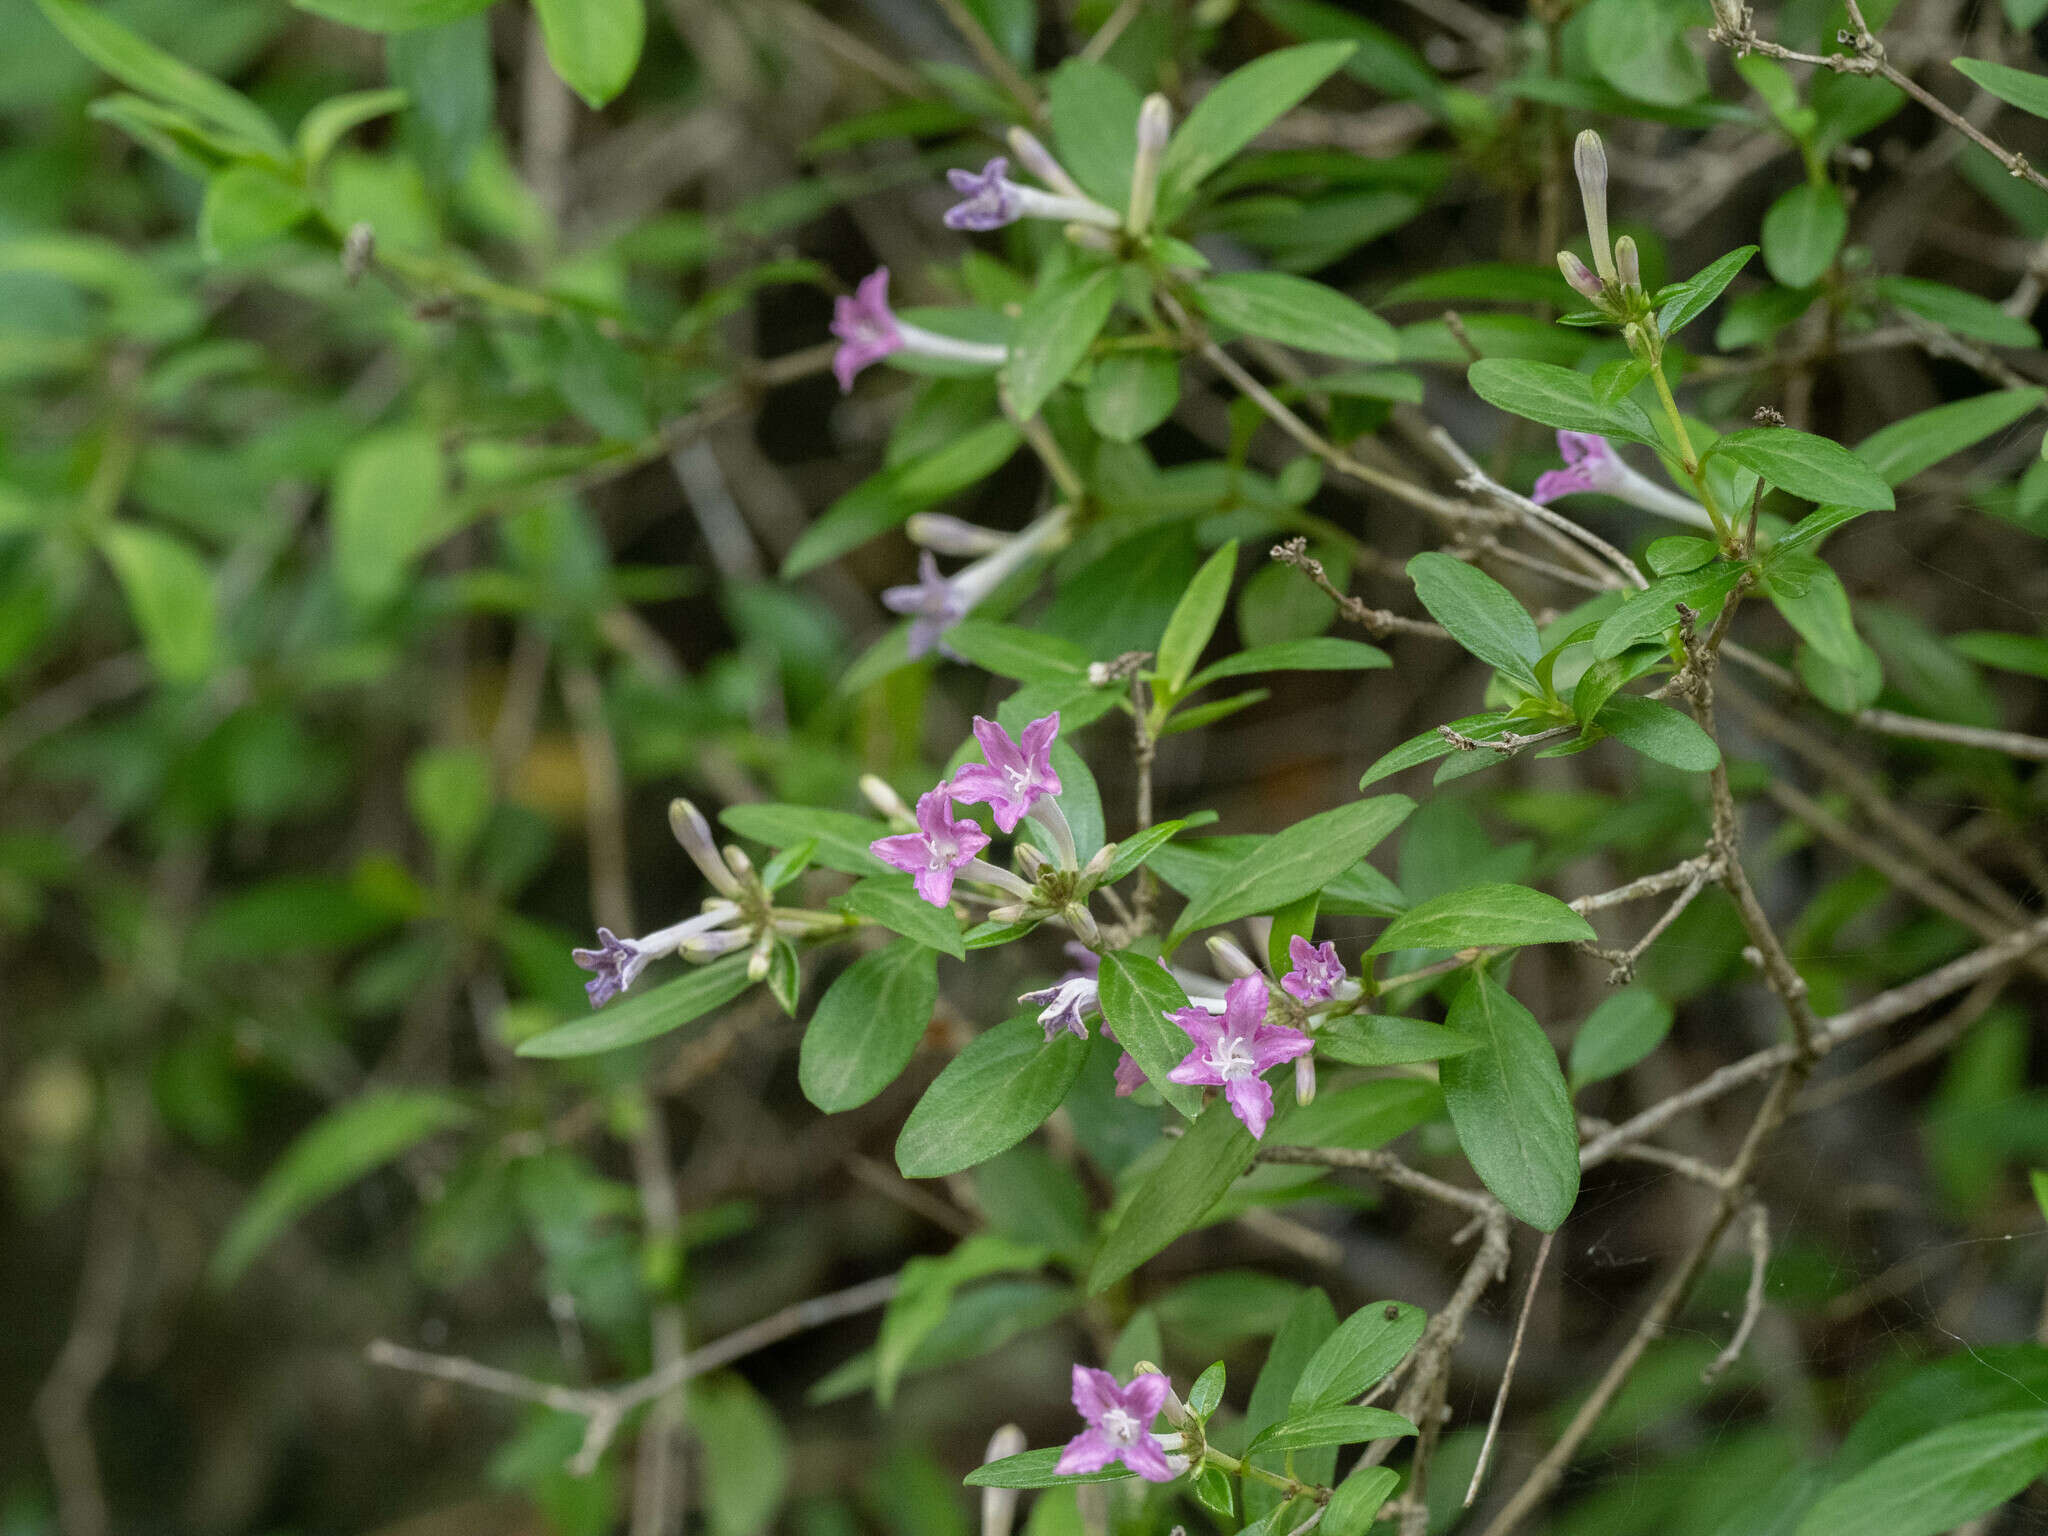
[569,801,858,1008]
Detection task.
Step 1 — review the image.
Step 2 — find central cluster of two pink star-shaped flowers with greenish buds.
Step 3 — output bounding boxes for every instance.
[868,711,1116,944]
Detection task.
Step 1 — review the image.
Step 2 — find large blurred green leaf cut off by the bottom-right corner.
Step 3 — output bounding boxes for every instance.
[1798,1407,2048,1536]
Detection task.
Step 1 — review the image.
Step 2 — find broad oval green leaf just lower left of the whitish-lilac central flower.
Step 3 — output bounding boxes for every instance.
[897,1014,1087,1180]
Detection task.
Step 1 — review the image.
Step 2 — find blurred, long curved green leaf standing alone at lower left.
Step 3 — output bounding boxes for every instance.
[207,1087,471,1286]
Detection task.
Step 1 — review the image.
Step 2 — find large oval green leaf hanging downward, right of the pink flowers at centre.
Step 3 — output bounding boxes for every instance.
[1438,974,1591,1233]
